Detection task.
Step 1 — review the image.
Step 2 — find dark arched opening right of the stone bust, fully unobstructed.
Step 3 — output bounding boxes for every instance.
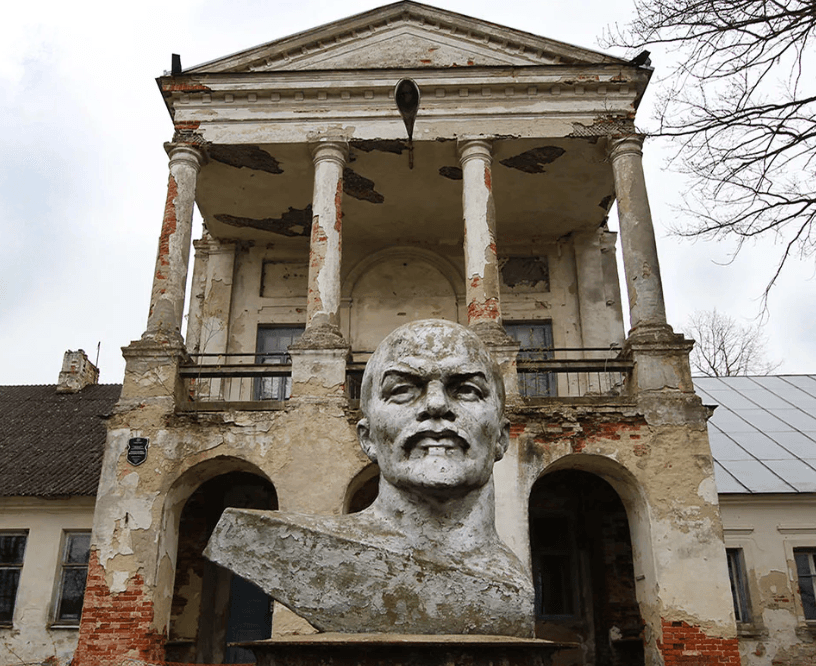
[529,469,644,666]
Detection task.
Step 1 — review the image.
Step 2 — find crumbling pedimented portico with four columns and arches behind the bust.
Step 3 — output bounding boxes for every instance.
[4,2,816,666]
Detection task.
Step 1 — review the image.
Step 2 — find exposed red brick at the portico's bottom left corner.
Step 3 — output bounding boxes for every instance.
[71,550,165,666]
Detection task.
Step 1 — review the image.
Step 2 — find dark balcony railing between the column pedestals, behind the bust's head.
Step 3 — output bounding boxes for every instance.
[178,347,633,412]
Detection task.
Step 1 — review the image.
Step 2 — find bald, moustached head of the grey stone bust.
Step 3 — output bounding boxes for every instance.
[357,320,509,491]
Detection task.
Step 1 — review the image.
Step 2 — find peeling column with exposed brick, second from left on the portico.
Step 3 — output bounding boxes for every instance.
[306,141,348,336]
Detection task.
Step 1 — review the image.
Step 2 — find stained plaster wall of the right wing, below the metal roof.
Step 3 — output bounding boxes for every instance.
[720,493,816,666]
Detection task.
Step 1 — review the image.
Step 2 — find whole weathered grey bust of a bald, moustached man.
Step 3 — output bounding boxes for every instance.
[205,320,533,636]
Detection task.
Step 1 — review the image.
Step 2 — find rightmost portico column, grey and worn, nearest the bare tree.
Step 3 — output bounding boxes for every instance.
[609,134,666,331]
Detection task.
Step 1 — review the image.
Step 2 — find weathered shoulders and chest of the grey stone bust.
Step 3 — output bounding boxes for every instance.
[204,509,533,636]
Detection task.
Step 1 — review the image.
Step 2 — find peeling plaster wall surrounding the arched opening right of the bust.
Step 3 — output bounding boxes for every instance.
[506,400,734,663]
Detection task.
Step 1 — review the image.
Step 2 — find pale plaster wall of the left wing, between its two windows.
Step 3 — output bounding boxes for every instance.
[0,497,94,664]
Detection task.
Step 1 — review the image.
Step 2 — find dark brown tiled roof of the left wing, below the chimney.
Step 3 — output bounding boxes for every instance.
[0,384,122,497]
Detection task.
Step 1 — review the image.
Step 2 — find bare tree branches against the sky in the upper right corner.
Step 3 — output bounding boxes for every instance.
[604,0,816,298]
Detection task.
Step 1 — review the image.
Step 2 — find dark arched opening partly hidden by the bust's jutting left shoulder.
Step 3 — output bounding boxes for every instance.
[166,471,278,664]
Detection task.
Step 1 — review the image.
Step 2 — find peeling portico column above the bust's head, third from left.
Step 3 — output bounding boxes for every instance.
[459,139,501,327]
